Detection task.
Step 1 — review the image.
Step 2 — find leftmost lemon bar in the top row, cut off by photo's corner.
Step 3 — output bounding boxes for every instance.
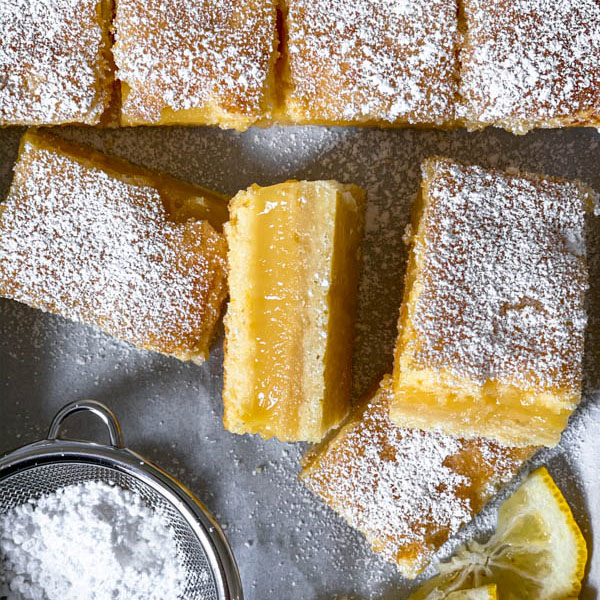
[0,0,113,126]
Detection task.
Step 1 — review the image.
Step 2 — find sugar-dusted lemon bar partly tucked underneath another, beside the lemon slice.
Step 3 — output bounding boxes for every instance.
[300,376,535,578]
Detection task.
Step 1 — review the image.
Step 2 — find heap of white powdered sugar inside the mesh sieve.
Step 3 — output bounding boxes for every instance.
[0,481,187,600]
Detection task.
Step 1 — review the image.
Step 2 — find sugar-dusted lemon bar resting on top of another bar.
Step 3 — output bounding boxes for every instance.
[390,158,594,446]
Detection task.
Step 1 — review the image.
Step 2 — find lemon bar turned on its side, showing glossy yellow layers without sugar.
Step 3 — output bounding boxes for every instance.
[223,181,365,441]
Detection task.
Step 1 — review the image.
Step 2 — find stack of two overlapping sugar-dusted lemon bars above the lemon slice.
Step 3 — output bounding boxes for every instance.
[301,158,594,577]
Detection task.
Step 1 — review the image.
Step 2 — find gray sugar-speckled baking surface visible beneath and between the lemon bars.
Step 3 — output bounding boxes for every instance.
[0,127,600,600]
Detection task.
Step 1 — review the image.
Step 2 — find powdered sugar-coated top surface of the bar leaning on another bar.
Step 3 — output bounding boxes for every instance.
[411,159,593,392]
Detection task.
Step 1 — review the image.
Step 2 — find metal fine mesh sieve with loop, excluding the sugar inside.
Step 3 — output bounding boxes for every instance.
[0,400,242,600]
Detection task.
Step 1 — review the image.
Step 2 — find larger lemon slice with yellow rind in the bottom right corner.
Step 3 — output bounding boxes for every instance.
[410,467,587,600]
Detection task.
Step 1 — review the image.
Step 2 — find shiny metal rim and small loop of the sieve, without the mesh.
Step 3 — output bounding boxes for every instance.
[0,400,243,600]
